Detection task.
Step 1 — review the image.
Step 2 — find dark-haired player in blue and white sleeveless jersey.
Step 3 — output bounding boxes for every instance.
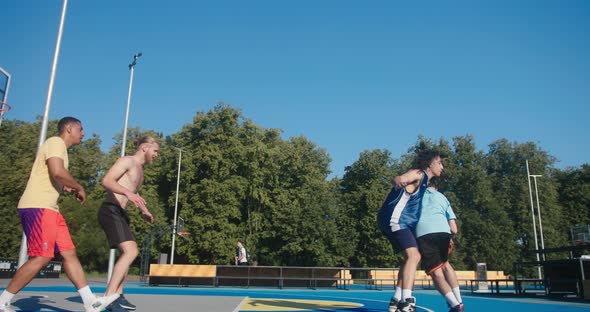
[377,149,444,312]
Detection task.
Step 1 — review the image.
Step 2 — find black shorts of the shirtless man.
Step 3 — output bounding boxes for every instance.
[98,202,135,248]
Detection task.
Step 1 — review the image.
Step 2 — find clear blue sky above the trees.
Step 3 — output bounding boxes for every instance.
[0,0,590,176]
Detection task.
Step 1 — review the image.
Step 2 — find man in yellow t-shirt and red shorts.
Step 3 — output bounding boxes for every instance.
[0,117,119,312]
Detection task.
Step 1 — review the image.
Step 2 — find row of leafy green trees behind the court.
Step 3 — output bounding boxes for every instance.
[0,103,590,272]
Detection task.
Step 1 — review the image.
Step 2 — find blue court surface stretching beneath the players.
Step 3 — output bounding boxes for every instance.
[0,279,590,312]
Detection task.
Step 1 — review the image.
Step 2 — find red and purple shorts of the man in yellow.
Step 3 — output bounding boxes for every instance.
[18,208,76,258]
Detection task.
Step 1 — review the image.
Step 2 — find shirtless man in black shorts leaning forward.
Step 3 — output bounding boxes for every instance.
[98,136,160,311]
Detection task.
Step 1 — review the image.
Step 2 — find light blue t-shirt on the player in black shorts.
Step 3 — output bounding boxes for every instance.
[416,188,457,237]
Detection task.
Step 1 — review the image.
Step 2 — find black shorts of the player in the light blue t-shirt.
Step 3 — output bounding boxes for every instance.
[418,232,451,274]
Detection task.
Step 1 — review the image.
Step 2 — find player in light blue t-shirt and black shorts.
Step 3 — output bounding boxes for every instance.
[416,179,465,312]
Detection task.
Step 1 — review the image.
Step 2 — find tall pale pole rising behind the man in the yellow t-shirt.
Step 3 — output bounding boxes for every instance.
[18,0,68,268]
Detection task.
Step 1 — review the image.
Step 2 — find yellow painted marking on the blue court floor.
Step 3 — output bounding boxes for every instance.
[240,298,363,311]
